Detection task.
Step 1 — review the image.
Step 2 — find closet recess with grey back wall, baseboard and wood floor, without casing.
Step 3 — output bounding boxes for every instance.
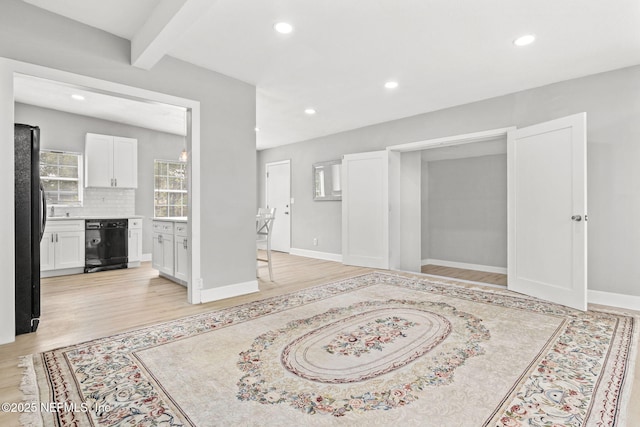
[420,135,508,287]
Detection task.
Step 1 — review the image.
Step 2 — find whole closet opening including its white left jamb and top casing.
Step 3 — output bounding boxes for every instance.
[387,128,514,287]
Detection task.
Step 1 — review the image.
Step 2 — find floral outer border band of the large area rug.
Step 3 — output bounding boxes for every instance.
[21,272,638,426]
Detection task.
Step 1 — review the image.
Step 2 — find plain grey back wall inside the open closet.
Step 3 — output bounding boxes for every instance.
[422,154,507,269]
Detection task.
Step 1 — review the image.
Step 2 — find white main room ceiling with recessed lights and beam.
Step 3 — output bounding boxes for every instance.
[17,0,640,149]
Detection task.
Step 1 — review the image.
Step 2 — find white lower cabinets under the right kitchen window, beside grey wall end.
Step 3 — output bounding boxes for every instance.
[151,220,189,285]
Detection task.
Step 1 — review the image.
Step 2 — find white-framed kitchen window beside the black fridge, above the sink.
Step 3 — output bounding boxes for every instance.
[40,150,82,206]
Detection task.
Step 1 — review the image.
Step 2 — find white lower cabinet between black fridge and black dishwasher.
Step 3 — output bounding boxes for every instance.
[40,220,85,277]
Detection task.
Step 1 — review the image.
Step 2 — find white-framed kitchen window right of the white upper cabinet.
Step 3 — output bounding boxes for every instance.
[153,160,188,218]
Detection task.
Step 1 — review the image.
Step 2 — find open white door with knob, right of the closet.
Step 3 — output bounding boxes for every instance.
[507,113,587,310]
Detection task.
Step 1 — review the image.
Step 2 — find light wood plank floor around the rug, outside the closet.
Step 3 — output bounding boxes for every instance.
[0,253,640,426]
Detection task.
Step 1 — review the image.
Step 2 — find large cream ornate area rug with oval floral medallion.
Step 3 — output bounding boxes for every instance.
[23,273,638,427]
